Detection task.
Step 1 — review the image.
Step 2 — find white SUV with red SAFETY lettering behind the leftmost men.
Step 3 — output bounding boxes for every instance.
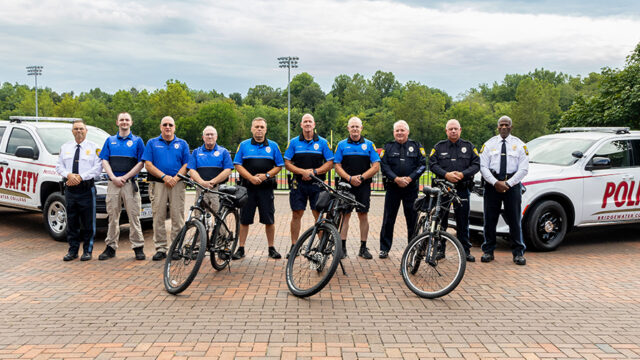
[0,116,152,241]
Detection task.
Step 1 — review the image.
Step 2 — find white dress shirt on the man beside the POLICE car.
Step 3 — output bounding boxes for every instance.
[480,135,529,186]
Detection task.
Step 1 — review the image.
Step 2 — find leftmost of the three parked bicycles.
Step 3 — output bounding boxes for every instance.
[164,174,247,294]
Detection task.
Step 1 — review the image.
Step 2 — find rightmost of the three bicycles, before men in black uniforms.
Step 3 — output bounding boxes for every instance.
[400,179,467,299]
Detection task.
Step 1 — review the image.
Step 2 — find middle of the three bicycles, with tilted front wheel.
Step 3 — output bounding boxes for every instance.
[286,175,364,297]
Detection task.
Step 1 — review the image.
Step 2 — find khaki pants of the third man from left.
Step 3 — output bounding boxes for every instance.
[149,181,185,253]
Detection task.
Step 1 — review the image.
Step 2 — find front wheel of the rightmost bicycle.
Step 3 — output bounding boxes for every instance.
[400,231,467,299]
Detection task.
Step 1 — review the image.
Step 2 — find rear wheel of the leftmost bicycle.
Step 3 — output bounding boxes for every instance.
[209,208,240,271]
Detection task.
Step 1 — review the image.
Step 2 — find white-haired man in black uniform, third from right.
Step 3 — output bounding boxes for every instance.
[380,120,426,259]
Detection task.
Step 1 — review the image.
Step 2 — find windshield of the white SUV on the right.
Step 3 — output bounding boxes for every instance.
[527,137,595,166]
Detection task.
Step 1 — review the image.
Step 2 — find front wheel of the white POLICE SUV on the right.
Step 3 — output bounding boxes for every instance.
[522,200,569,251]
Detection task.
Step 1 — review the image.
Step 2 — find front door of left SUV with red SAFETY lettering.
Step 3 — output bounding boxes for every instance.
[0,126,40,208]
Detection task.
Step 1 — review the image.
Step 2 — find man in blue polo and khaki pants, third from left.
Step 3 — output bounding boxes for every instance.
[142,116,189,261]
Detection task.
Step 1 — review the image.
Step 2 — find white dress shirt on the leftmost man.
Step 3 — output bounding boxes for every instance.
[56,139,102,180]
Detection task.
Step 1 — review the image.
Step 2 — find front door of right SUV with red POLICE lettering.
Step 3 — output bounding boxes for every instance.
[582,140,640,223]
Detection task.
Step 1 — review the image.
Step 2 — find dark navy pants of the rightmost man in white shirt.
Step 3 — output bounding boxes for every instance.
[482,183,526,256]
